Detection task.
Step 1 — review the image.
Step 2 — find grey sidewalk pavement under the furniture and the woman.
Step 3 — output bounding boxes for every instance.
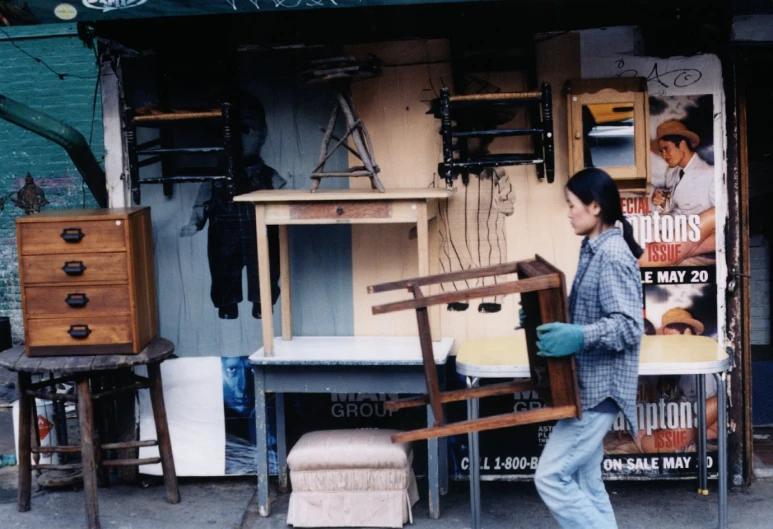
[0,460,773,529]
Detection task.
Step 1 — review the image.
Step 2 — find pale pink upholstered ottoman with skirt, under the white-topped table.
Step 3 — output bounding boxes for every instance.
[287,429,419,527]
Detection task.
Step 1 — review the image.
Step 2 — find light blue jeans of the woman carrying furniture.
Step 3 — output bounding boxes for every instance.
[534,399,618,529]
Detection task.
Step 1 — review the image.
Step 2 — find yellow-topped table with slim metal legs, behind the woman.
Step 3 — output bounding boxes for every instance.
[456,335,732,529]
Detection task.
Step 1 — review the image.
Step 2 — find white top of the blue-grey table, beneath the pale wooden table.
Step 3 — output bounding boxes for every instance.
[250,336,454,366]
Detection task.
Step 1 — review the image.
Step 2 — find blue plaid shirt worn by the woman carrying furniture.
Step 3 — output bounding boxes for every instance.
[569,228,644,435]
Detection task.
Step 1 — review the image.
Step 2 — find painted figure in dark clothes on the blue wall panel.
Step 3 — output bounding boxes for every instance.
[180,91,287,320]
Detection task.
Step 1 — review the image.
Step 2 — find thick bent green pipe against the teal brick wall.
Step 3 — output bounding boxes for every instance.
[0,94,107,208]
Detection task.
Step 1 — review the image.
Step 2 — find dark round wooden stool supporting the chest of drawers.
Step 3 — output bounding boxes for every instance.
[0,338,180,529]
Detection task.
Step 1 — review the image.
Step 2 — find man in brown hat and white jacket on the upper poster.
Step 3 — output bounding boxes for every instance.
[652,119,714,215]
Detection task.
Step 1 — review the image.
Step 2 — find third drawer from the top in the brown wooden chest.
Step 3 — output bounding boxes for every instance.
[24,285,131,318]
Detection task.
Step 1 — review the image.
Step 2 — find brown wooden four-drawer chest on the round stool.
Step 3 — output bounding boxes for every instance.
[16,207,158,356]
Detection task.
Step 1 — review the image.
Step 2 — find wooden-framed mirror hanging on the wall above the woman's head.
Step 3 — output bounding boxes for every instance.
[565,77,650,191]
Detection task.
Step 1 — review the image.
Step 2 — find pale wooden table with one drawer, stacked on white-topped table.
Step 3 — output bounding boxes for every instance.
[234,188,452,356]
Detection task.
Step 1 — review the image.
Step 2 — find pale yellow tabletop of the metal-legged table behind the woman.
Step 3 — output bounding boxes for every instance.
[456,332,731,378]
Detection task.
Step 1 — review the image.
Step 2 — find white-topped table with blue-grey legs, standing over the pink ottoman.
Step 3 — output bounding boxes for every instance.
[250,336,453,518]
